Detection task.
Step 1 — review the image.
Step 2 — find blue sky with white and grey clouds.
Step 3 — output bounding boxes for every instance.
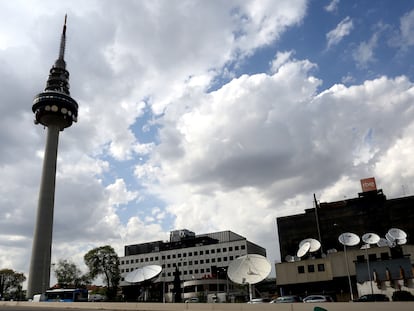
[0,0,414,286]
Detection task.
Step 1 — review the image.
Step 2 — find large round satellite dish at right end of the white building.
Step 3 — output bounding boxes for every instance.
[227,254,271,284]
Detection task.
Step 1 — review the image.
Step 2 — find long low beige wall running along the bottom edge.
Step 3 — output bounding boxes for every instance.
[0,301,414,311]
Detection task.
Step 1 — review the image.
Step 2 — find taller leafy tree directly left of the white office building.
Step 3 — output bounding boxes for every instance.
[84,245,121,300]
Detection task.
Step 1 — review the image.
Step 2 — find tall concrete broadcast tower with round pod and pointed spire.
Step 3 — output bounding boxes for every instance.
[27,16,78,298]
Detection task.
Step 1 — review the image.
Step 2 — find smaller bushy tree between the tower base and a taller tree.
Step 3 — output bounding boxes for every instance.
[53,259,87,288]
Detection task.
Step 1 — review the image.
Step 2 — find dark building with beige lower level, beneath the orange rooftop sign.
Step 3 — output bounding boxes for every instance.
[276,180,414,301]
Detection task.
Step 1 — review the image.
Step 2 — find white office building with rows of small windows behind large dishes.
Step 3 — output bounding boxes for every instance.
[120,229,266,299]
